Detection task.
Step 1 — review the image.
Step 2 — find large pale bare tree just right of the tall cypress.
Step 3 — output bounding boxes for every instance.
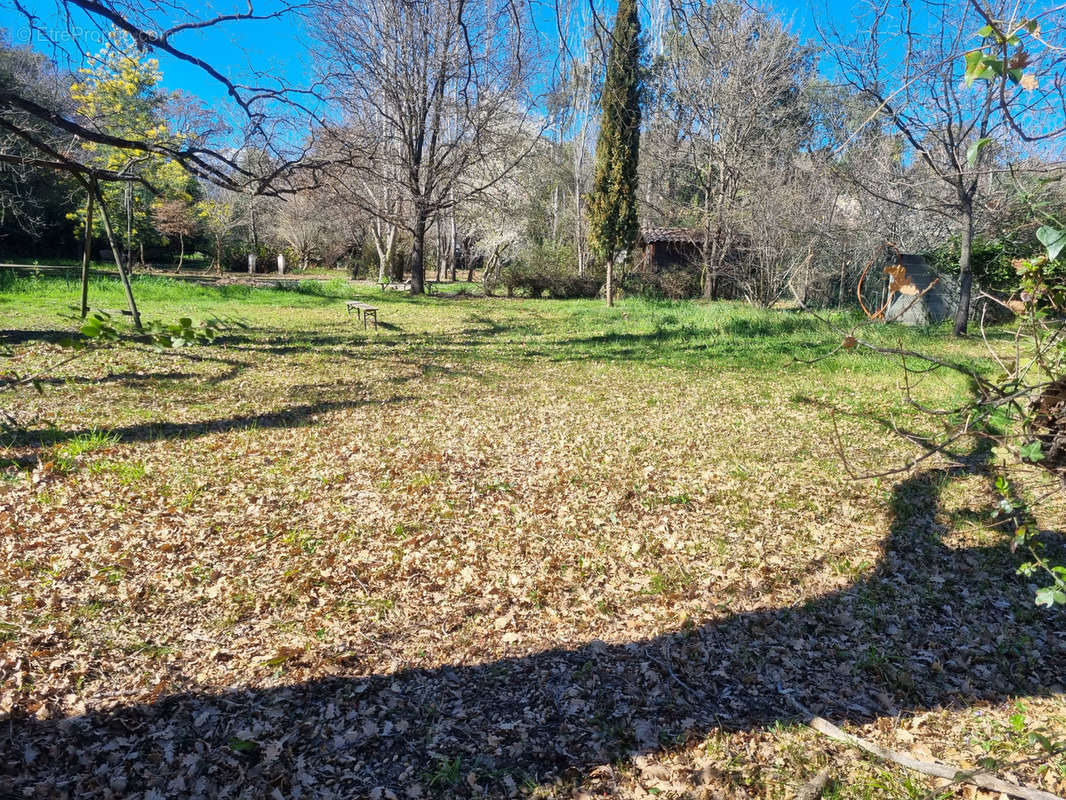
[648,0,813,302]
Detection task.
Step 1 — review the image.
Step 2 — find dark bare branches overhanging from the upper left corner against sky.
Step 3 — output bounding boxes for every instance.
[0,0,326,192]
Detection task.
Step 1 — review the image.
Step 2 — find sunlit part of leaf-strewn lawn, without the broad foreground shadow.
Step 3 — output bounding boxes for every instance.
[0,273,1050,798]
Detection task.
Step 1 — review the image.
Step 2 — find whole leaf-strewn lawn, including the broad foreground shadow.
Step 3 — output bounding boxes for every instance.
[0,277,1066,800]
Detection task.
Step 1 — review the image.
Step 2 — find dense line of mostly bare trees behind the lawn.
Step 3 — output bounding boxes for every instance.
[0,0,1062,315]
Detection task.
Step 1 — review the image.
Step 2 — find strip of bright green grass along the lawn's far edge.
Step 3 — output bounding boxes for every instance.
[0,276,984,392]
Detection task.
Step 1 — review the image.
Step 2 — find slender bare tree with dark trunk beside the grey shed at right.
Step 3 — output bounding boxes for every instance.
[823,0,1054,335]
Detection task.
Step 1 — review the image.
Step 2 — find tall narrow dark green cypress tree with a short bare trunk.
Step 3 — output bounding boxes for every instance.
[588,0,641,305]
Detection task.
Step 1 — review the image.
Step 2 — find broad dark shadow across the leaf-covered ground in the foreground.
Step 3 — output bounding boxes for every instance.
[0,441,1066,798]
